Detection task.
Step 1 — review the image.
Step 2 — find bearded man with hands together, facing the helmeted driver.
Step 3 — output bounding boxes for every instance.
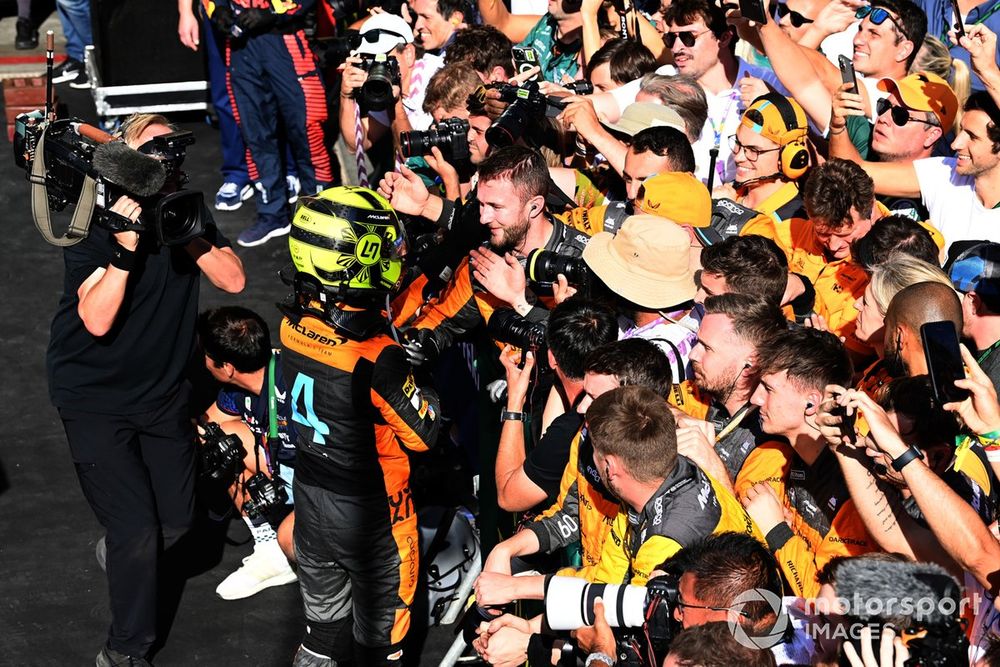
[396,146,587,363]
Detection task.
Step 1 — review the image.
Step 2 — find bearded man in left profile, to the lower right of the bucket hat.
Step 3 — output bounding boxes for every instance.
[677,294,787,495]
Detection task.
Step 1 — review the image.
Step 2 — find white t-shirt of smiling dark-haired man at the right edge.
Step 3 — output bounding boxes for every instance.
[913,157,1000,251]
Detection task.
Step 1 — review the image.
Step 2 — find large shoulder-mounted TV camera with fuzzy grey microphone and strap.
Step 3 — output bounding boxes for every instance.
[14,111,205,246]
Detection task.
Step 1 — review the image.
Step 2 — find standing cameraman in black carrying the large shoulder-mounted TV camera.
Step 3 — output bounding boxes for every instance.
[47,114,245,665]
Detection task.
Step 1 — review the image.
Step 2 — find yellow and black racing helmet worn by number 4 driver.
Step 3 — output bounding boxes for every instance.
[288,185,406,300]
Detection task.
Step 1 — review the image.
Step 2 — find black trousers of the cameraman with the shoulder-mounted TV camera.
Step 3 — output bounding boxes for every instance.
[59,391,195,656]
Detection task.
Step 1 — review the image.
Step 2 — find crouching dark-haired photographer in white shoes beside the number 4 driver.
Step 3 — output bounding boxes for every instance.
[198,306,296,600]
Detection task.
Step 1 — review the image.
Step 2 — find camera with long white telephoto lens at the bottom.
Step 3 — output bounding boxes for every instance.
[545,573,681,667]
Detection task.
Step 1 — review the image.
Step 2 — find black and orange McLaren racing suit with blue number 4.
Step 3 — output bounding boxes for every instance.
[281,317,439,664]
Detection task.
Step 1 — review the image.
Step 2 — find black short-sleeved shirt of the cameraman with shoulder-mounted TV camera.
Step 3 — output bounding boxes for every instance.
[47,214,231,414]
